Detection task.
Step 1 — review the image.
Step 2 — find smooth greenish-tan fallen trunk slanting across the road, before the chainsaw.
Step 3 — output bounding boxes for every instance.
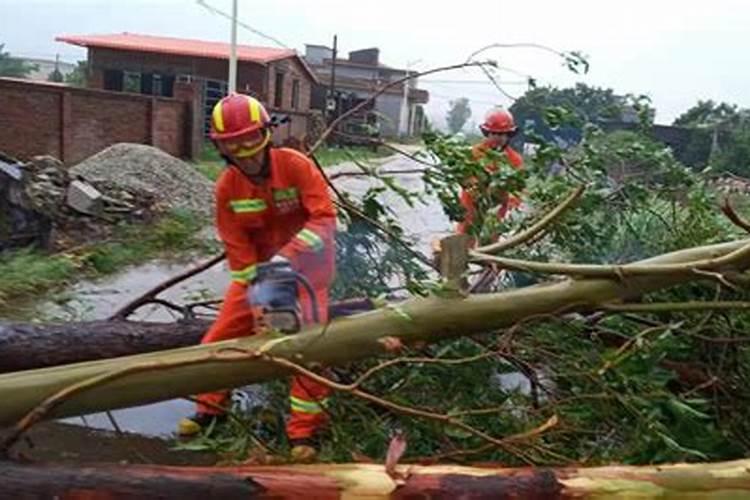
[0,240,750,425]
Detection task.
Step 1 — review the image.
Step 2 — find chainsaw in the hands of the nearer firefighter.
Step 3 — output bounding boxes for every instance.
[248,261,320,335]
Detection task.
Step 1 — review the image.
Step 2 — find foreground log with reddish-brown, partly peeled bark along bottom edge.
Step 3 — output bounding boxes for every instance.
[0,460,750,500]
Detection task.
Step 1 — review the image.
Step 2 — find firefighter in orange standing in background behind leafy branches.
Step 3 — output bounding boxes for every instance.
[456,109,523,234]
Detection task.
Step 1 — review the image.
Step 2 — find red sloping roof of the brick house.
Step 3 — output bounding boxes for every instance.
[55,33,297,64]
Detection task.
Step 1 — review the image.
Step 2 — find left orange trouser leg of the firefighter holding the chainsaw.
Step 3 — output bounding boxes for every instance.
[196,283,253,415]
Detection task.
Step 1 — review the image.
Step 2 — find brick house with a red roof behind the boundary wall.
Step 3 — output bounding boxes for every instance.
[57,33,317,146]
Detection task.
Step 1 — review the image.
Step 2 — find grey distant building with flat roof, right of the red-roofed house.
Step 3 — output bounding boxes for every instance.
[305,44,429,137]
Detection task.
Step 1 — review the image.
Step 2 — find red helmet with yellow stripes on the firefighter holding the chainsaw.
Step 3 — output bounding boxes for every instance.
[209,94,271,141]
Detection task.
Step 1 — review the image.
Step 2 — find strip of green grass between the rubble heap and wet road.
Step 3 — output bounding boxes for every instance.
[0,211,212,311]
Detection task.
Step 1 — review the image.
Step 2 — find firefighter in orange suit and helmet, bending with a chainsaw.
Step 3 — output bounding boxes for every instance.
[178,94,336,458]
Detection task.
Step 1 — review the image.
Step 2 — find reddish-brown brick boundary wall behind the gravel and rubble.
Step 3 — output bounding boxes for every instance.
[0,78,192,164]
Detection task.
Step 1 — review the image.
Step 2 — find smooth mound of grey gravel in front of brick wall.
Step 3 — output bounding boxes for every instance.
[70,143,213,216]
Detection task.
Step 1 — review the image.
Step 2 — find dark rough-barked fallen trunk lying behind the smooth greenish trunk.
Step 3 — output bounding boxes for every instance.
[0,299,375,373]
